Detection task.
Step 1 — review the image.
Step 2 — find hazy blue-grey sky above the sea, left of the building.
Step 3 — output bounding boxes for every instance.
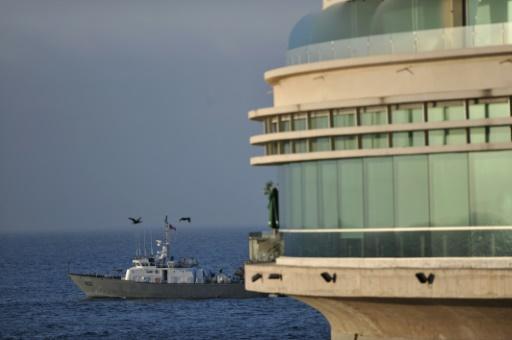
[0,0,321,231]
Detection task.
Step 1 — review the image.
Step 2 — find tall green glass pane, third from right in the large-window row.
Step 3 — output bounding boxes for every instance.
[394,155,429,227]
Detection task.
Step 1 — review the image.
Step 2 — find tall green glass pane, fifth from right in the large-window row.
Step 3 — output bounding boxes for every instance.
[338,159,364,228]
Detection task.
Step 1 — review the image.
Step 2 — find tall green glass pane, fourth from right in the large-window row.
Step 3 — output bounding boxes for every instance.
[364,157,395,227]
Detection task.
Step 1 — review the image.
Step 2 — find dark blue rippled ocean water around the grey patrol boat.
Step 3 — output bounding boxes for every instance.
[0,227,329,339]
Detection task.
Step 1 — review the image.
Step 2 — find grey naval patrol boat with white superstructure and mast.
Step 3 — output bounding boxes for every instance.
[69,218,263,299]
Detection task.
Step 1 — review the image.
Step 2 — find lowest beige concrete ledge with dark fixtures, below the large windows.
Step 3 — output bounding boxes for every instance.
[245,259,512,300]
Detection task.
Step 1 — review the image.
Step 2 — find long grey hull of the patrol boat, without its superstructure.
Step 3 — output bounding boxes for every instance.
[69,274,265,299]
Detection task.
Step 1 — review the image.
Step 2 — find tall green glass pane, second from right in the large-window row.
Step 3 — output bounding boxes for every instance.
[429,153,470,226]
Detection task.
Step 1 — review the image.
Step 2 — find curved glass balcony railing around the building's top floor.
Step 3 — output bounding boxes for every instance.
[286,22,512,65]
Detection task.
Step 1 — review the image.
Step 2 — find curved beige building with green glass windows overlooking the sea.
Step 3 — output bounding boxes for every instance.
[246,0,512,339]
